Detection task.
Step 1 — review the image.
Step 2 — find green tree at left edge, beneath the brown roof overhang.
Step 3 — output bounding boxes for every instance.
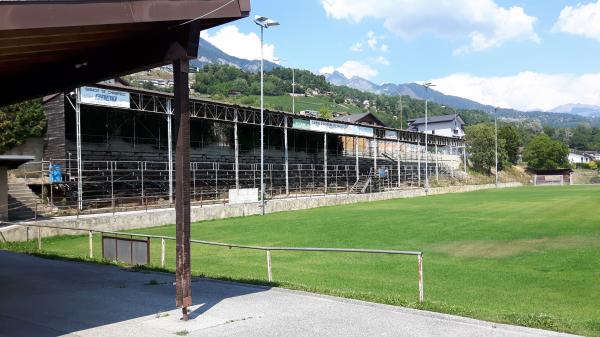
[0,99,46,153]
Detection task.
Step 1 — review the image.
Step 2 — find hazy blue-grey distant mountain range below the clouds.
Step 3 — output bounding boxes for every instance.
[190,38,600,127]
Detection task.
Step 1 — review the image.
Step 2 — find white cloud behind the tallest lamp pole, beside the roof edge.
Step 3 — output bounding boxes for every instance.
[200,25,277,62]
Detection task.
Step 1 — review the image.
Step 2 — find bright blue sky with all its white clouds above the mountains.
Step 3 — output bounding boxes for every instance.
[205,0,600,110]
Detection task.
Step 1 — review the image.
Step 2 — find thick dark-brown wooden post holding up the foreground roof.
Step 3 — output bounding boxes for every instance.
[173,57,192,321]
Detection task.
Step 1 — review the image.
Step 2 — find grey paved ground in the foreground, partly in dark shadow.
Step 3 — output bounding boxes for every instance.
[0,251,580,337]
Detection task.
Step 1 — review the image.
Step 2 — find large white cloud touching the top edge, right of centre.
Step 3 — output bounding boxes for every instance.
[321,0,539,54]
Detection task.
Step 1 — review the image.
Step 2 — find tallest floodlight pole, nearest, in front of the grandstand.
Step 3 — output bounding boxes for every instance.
[254,15,279,215]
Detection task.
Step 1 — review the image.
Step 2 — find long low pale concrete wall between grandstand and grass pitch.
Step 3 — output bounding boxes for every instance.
[0,183,522,241]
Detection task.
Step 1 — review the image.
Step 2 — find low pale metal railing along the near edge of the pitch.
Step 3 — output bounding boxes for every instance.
[4,224,425,303]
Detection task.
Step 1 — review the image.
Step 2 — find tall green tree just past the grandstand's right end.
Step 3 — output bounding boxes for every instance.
[465,124,507,173]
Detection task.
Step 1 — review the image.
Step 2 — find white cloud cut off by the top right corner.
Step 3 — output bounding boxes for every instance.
[552,0,600,41]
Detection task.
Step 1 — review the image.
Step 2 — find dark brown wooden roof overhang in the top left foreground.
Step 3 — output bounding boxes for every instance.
[0,0,250,105]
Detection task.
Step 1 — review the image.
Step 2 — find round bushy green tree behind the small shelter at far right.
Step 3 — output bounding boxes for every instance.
[523,134,569,170]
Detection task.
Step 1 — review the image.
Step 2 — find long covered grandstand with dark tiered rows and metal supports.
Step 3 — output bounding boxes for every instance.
[22,83,465,213]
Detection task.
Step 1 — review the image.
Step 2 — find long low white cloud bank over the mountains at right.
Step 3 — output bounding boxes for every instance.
[431,72,600,111]
